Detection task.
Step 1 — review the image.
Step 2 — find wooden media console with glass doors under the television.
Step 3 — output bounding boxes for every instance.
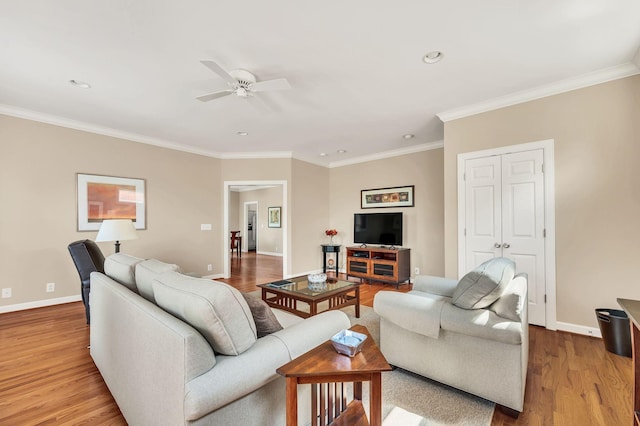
[347,246,411,287]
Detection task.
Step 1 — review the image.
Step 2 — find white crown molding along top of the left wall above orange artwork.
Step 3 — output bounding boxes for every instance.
[0,104,225,158]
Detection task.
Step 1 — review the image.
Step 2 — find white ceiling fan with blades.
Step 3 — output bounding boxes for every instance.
[196,61,291,102]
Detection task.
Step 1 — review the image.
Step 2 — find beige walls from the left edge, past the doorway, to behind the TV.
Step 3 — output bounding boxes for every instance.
[0,116,444,307]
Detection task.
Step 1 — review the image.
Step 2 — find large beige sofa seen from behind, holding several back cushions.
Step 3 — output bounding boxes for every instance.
[90,254,350,426]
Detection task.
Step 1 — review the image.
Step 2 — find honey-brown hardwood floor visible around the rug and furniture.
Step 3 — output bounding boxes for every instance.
[0,253,633,426]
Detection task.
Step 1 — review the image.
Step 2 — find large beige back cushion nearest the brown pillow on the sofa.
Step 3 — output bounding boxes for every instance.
[153,272,256,355]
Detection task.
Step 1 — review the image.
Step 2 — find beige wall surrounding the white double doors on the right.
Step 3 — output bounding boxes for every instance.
[444,76,640,327]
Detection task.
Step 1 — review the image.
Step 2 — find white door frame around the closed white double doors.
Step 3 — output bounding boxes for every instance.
[458,139,557,330]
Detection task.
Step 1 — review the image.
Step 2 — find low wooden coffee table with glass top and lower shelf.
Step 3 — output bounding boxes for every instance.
[258,276,360,318]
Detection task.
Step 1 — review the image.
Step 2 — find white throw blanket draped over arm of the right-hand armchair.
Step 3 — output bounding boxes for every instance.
[373,291,451,339]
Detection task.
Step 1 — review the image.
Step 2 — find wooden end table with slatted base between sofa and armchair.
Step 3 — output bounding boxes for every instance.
[276,325,391,426]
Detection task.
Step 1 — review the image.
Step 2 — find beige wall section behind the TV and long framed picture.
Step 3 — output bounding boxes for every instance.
[325,149,444,276]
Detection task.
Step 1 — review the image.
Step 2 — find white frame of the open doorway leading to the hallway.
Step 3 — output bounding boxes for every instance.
[222,180,289,278]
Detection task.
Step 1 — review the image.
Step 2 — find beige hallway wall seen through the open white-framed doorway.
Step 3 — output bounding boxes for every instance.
[238,185,283,255]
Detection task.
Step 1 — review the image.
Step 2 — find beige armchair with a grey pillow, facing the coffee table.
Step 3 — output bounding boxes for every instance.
[374,258,529,416]
